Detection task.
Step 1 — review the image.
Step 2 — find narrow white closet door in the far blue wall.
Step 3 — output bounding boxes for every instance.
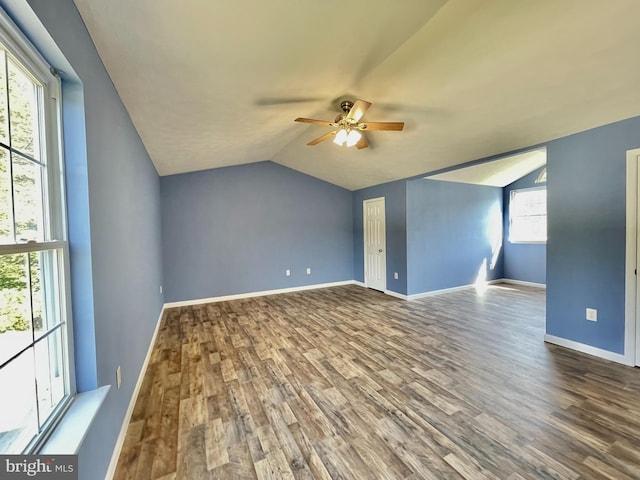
[363,197,387,292]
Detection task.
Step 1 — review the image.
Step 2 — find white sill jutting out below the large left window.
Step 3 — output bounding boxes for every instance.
[38,385,111,455]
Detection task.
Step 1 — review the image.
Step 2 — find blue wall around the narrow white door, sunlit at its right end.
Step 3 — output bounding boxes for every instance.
[353,178,503,295]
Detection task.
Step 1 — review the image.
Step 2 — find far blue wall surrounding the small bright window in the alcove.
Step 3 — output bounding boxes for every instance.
[503,167,547,284]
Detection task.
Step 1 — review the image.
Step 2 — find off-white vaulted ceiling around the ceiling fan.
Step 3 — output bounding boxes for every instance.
[75,0,640,189]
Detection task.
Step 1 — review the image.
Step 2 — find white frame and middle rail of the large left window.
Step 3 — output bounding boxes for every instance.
[0,8,77,453]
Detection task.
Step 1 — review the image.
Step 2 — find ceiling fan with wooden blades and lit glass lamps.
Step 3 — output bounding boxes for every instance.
[295,100,404,149]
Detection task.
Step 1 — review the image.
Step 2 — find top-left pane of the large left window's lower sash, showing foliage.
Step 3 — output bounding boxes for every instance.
[0,253,33,364]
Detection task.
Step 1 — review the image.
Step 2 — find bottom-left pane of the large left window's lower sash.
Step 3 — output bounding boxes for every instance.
[0,348,38,454]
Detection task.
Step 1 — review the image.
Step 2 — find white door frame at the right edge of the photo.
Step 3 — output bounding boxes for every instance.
[624,148,640,365]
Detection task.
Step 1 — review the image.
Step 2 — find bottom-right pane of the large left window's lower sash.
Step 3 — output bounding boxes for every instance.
[35,329,65,426]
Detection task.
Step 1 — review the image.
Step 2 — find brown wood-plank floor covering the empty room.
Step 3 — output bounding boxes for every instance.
[115,285,640,480]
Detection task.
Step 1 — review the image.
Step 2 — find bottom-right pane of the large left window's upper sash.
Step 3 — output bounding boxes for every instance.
[12,154,44,242]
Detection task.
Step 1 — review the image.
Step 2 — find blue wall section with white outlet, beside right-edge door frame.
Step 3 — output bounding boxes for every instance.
[547,117,640,354]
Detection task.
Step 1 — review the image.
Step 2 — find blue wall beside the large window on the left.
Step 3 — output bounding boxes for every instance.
[10,0,163,480]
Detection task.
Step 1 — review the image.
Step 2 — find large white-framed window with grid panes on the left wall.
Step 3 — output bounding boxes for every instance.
[0,11,74,454]
